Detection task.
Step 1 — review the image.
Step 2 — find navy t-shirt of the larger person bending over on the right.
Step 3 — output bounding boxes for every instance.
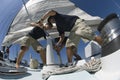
[53,13,79,35]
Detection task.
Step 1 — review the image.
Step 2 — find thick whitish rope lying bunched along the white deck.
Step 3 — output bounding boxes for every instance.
[42,59,101,80]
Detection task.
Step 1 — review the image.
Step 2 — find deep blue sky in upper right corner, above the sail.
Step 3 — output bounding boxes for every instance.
[71,0,120,18]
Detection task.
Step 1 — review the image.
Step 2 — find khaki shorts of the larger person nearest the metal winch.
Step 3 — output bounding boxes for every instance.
[66,19,95,48]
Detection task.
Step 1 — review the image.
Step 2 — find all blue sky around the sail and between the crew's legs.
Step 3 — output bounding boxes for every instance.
[0,0,120,63]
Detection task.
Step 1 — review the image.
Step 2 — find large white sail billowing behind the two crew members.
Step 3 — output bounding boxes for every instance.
[3,0,101,46]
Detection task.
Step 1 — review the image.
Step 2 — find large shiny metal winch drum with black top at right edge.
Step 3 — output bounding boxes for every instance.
[98,13,120,57]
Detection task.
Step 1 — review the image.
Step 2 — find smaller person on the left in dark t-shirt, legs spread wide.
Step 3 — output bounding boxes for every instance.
[16,22,50,68]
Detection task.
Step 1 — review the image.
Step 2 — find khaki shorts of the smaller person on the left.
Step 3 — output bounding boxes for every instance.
[20,35,44,52]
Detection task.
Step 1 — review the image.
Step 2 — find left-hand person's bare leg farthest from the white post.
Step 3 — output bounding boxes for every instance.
[15,47,28,68]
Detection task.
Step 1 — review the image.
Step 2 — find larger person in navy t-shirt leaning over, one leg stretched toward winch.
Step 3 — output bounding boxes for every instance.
[36,10,102,64]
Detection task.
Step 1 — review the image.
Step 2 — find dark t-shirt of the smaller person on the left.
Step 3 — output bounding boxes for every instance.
[28,27,46,39]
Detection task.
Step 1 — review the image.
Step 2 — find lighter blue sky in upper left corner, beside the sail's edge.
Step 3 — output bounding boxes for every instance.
[0,0,22,45]
